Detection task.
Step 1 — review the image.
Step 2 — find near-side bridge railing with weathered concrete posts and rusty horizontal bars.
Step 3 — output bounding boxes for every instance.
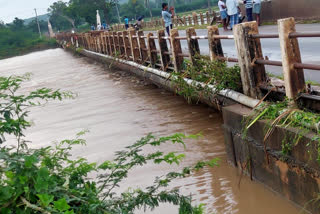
[57,18,320,106]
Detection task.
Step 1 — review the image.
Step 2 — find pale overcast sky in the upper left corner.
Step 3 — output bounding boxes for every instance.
[0,0,67,23]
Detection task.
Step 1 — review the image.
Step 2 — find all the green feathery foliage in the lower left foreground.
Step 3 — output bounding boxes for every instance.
[0,76,218,214]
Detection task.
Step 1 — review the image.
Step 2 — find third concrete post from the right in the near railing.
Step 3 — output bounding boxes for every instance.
[207,26,224,60]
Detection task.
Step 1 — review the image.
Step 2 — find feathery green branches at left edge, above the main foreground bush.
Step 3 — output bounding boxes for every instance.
[0,74,74,149]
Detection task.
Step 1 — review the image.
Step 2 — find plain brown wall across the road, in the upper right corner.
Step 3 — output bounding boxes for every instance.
[261,0,320,21]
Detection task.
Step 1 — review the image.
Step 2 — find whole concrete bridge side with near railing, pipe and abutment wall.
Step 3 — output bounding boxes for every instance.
[57,18,320,213]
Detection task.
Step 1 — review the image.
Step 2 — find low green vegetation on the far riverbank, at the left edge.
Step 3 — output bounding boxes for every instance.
[0,27,57,60]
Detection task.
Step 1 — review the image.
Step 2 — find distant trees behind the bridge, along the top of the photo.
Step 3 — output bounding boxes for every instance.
[48,0,218,31]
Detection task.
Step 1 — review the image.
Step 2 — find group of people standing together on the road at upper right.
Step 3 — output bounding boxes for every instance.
[218,0,261,30]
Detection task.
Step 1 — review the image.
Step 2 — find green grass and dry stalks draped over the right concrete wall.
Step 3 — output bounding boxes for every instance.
[243,99,320,164]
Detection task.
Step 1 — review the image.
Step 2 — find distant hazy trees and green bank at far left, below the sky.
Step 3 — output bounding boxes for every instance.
[0,18,56,59]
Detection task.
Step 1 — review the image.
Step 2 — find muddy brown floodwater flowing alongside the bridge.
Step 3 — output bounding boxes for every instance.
[0,49,300,214]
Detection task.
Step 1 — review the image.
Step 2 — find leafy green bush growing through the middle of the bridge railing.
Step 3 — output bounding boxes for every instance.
[173,56,242,102]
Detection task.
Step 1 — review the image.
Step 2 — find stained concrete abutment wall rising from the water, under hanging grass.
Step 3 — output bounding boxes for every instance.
[223,104,320,213]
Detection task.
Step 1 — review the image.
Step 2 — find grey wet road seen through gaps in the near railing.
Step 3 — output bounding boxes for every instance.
[152,24,320,83]
